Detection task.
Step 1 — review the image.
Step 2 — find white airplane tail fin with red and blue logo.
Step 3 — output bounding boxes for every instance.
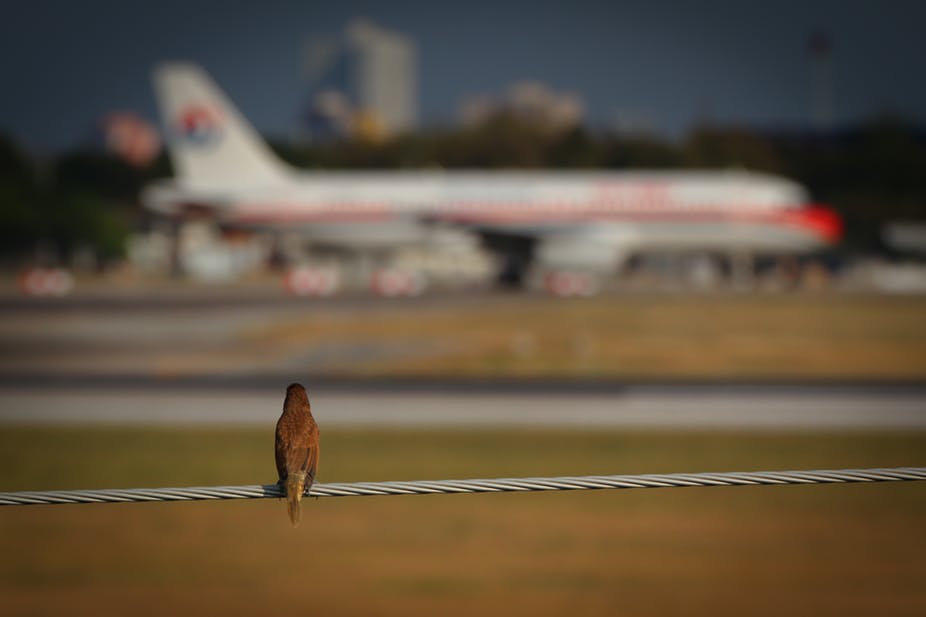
[153,62,290,189]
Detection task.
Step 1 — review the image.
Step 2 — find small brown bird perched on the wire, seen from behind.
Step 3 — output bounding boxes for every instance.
[274,383,318,527]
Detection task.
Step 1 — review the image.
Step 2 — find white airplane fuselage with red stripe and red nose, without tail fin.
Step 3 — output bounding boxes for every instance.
[146,171,840,252]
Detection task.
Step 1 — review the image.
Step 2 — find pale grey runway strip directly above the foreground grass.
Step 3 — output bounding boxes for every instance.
[0,384,926,431]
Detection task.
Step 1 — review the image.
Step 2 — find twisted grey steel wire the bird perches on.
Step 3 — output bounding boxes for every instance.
[0,467,926,506]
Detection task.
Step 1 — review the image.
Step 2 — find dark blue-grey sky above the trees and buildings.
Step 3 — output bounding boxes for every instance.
[0,0,926,152]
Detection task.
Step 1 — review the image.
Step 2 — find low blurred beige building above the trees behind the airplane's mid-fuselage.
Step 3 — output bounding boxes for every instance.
[460,81,585,130]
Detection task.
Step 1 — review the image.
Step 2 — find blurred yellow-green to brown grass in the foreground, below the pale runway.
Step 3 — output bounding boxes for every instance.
[0,426,926,617]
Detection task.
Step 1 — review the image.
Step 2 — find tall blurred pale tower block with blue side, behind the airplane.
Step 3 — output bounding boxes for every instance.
[307,19,418,139]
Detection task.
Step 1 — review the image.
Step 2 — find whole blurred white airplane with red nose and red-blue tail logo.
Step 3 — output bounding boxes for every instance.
[142,62,843,295]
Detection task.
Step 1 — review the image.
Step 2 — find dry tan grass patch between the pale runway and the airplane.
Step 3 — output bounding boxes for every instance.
[241,294,926,380]
